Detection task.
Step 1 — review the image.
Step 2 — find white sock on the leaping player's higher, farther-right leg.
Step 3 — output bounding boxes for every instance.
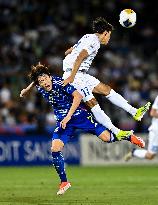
[106,89,137,116]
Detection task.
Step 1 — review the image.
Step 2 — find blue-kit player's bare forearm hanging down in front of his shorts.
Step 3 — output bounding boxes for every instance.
[60,90,83,129]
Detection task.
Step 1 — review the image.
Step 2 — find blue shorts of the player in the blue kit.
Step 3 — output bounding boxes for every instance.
[52,111,107,144]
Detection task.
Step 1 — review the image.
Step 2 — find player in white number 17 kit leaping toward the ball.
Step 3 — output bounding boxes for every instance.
[63,17,150,136]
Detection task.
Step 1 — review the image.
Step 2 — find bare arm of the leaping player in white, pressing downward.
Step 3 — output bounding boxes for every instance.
[63,49,89,86]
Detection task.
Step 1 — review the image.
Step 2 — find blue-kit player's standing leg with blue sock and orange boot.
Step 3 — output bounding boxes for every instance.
[51,139,71,195]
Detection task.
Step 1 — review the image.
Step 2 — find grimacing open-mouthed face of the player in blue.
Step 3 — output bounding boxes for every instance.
[38,74,52,91]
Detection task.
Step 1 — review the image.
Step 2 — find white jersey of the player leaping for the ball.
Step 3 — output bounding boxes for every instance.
[63,34,100,71]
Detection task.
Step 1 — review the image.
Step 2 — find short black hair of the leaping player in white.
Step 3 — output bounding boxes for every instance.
[93,17,114,34]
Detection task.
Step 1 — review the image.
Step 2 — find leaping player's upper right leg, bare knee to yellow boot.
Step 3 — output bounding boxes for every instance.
[93,83,151,121]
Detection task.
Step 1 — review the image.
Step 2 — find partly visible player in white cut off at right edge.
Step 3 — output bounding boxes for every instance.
[124,96,158,161]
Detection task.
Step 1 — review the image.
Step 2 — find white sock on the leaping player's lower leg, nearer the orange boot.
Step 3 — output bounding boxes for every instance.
[91,104,120,135]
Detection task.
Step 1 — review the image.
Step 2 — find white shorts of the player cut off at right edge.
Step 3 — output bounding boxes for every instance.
[148,130,158,153]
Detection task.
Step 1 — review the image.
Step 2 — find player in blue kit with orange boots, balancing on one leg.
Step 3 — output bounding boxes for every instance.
[20,64,145,195]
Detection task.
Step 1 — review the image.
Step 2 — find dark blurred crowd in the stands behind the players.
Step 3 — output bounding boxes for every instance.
[0,0,158,134]
